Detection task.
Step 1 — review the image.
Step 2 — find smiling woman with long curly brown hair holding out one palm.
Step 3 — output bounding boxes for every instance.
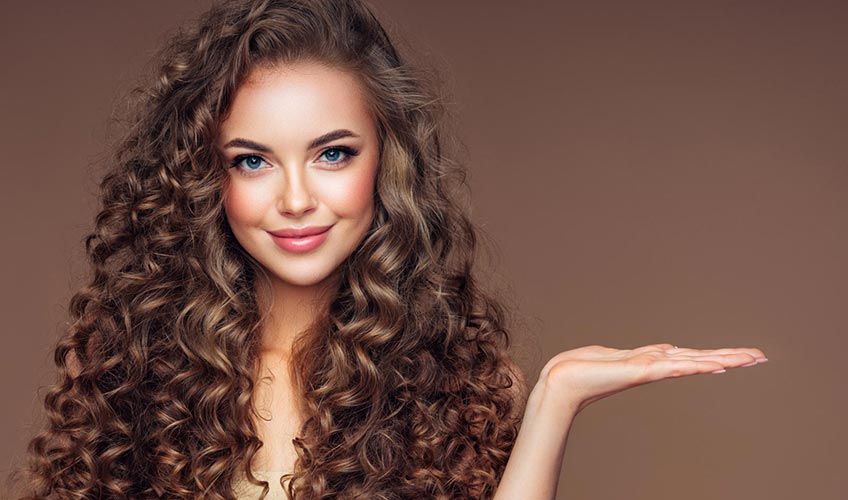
[4,0,765,500]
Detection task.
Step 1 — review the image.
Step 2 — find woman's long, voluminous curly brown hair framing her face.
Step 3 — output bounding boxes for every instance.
[4,0,523,500]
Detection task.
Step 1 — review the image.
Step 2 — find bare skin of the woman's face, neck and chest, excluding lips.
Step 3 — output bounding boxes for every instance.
[218,62,379,474]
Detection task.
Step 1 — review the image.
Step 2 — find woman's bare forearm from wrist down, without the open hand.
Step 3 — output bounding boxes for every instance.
[494,378,577,500]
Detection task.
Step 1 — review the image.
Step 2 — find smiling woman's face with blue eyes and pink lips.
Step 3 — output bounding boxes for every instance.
[219,62,379,286]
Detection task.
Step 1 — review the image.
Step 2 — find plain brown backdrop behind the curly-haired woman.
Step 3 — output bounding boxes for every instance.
[0,0,848,500]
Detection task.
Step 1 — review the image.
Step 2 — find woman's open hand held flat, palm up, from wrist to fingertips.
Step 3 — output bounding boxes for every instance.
[528,344,768,415]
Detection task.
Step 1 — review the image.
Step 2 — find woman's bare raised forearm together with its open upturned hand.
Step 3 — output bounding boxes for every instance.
[494,344,768,500]
